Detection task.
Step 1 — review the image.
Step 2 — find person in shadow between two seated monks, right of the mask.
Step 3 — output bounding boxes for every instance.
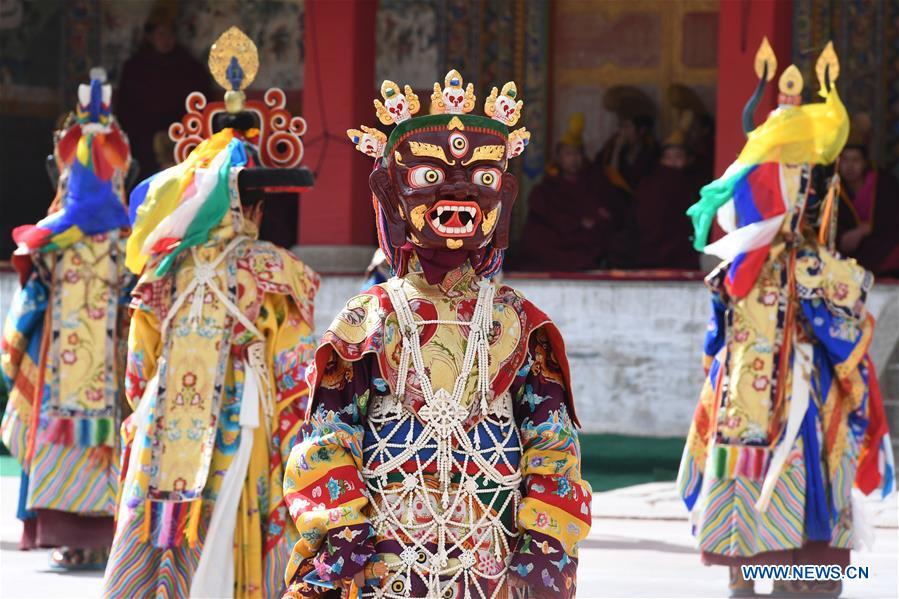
[589,86,659,268]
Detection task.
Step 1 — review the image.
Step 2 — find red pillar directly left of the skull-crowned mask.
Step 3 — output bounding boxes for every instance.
[298,0,377,245]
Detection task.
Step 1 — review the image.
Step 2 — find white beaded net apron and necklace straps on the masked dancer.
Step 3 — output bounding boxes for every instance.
[363,278,521,599]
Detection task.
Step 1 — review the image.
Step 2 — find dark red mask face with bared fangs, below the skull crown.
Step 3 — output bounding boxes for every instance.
[369,129,518,251]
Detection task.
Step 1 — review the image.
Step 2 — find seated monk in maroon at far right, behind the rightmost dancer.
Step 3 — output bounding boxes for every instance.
[837,114,899,277]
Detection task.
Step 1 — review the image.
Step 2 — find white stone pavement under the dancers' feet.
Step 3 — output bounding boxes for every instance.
[0,477,899,599]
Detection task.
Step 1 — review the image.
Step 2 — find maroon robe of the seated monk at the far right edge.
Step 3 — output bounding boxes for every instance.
[837,171,899,277]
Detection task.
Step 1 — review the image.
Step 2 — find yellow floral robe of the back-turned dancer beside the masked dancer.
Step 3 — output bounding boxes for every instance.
[104,225,318,598]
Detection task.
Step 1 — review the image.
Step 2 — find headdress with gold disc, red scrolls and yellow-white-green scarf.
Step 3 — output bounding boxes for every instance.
[126,27,312,275]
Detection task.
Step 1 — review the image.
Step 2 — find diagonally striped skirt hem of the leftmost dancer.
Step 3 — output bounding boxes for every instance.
[28,443,118,516]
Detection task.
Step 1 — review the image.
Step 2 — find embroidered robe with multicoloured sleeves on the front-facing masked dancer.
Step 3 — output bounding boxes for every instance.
[284,264,591,597]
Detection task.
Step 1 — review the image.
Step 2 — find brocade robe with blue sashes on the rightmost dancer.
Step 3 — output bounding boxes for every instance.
[678,235,895,566]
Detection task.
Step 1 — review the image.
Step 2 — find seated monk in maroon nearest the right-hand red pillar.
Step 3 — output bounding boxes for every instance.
[636,129,700,270]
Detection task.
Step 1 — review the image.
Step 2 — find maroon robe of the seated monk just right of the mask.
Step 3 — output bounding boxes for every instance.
[511,175,604,271]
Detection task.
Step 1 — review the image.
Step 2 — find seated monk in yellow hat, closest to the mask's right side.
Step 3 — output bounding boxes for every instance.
[513,113,609,271]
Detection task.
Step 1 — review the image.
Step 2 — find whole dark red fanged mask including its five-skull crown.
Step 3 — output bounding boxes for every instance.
[347,70,530,274]
